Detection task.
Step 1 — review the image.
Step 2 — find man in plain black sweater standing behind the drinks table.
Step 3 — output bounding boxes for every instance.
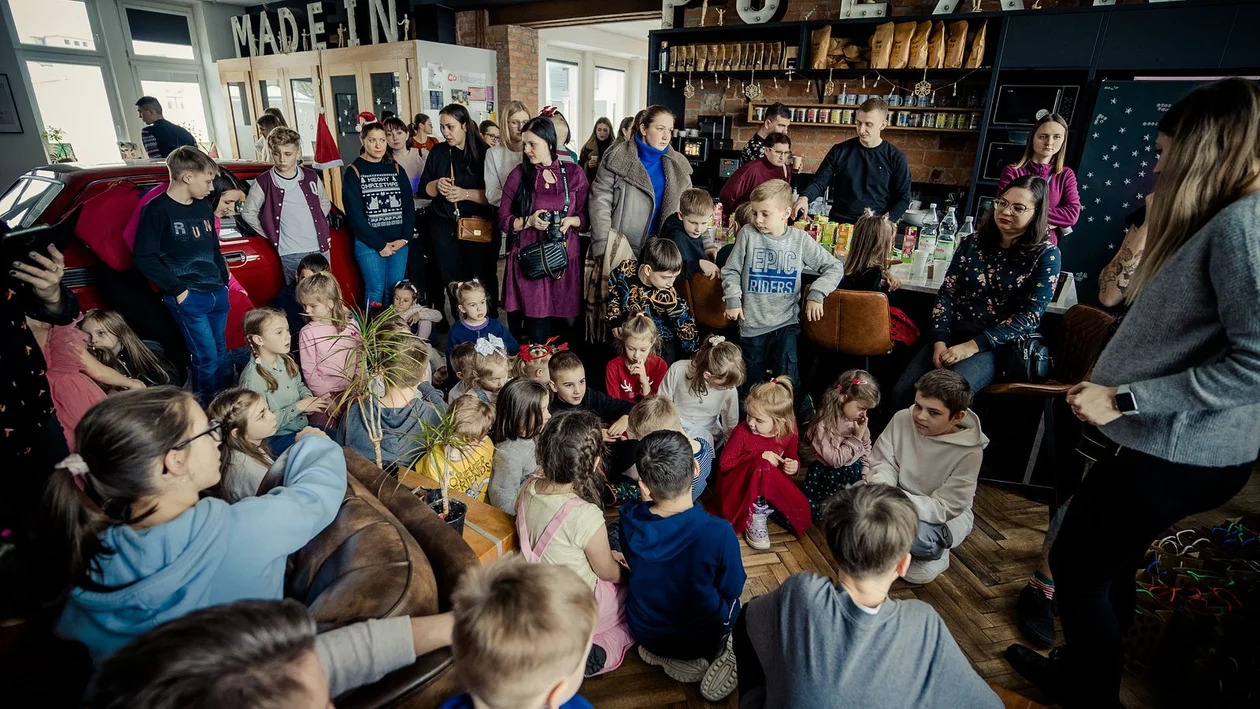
[793,98,910,224]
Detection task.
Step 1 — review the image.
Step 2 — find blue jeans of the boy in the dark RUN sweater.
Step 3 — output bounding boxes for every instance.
[161,286,231,403]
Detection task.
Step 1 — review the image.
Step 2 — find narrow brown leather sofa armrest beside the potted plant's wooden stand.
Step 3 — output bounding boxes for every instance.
[345,448,480,612]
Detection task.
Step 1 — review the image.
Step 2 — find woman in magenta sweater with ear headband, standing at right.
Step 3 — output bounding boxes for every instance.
[998,113,1081,244]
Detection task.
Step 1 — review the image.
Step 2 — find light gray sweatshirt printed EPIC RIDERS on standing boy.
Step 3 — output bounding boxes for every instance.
[722,224,844,337]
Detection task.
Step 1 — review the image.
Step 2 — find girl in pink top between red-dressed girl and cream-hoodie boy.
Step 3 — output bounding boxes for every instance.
[803,369,879,518]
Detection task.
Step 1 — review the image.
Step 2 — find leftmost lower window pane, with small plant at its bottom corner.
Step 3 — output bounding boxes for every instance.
[26,62,118,162]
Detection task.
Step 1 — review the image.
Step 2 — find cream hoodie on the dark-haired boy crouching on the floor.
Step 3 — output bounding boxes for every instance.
[867,408,989,524]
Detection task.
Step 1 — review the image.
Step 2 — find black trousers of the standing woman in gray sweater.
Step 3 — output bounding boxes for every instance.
[1043,448,1251,706]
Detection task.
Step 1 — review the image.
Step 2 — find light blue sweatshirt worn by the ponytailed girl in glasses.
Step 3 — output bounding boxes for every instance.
[55,436,345,667]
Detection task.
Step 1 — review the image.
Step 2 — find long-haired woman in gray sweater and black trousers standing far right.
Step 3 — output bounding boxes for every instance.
[1007,78,1260,706]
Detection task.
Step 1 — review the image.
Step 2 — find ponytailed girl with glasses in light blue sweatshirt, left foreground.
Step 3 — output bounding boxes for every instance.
[42,387,345,667]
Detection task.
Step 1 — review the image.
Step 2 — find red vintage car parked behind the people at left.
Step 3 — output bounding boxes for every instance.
[0,160,363,349]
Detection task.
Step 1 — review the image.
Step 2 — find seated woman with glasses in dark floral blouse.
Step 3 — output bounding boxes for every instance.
[893,175,1060,407]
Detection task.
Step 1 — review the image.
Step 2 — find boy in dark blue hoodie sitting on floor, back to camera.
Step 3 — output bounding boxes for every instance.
[621,431,747,701]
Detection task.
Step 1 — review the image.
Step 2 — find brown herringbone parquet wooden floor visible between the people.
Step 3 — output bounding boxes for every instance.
[582,472,1260,709]
